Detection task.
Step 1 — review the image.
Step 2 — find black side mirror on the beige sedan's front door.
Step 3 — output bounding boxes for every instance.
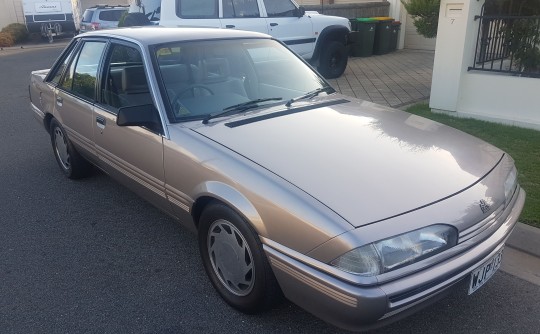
[116,104,162,133]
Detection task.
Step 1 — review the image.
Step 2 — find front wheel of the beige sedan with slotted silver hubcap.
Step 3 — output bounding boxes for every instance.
[199,202,282,314]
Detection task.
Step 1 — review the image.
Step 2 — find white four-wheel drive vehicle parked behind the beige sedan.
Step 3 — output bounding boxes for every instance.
[124,0,350,78]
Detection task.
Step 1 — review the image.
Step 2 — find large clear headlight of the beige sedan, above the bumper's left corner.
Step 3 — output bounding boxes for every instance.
[330,225,457,276]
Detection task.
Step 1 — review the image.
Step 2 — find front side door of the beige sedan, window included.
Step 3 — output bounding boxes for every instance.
[92,41,170,212]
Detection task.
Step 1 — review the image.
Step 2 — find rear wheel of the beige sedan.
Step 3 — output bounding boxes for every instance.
[50,118,92,179]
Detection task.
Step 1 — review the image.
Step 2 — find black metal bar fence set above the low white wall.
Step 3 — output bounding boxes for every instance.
[469,15,540,78]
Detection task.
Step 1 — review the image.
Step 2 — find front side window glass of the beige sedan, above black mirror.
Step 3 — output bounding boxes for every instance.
[101,44,153,113]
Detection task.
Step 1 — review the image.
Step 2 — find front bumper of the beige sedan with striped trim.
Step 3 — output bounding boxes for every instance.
[263,188,525,330]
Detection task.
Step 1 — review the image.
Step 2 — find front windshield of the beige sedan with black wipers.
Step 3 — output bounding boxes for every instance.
[154,39,332,123]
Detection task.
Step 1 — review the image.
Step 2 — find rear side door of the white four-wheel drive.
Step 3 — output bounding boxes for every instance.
[221,0,268,34]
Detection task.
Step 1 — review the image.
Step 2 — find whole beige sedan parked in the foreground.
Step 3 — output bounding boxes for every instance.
[30,27,525,330]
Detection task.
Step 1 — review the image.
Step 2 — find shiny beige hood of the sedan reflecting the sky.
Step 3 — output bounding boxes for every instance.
[192,95,504,227]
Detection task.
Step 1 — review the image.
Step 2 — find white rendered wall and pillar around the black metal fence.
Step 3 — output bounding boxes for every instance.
[429,0,540,130]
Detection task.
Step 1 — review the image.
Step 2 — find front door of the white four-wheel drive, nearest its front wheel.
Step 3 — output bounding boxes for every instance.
[263,0,314,57]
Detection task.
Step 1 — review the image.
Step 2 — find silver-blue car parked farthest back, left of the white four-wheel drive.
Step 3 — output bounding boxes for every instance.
[80,5,129,33]
